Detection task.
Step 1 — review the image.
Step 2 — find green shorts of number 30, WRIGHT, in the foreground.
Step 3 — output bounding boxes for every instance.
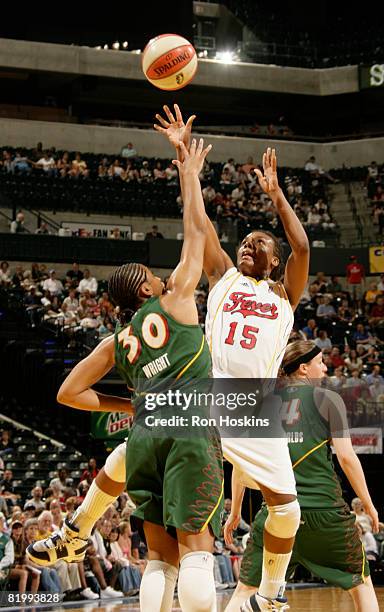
[127,424,224,537]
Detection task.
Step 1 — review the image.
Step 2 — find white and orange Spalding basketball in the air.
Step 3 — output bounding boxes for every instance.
[142,34,197,91]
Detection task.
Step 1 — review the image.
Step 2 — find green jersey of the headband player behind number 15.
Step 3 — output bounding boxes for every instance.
[279,385,345,510]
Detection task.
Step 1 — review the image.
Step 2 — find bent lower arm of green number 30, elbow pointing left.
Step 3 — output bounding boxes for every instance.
[57,336,134,415]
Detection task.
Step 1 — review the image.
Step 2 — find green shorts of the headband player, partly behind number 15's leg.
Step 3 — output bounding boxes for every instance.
[240,507,369,590]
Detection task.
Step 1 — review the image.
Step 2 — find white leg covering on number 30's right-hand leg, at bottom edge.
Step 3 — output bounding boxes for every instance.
[178,551,217,612]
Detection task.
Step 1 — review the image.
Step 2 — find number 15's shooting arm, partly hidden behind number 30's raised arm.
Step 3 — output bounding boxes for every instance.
[154,104,233,289]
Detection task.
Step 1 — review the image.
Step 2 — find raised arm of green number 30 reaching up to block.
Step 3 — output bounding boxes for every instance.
[161,138,212,324]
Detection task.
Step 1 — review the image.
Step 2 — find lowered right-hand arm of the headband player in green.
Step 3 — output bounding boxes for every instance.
[315,389,379,533]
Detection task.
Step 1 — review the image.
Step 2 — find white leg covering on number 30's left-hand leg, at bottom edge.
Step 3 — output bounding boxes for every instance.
[140,561,178,612]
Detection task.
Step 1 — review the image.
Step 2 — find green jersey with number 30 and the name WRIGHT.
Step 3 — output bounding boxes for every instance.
[115,297,211,414]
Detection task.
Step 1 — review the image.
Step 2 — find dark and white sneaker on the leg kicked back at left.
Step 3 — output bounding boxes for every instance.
[26,520,88,567]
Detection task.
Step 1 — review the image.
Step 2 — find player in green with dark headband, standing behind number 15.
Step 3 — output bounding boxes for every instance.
[224,340,379,612]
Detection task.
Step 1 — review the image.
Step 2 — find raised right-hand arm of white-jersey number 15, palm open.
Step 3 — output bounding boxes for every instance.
[255,147,310,309]
